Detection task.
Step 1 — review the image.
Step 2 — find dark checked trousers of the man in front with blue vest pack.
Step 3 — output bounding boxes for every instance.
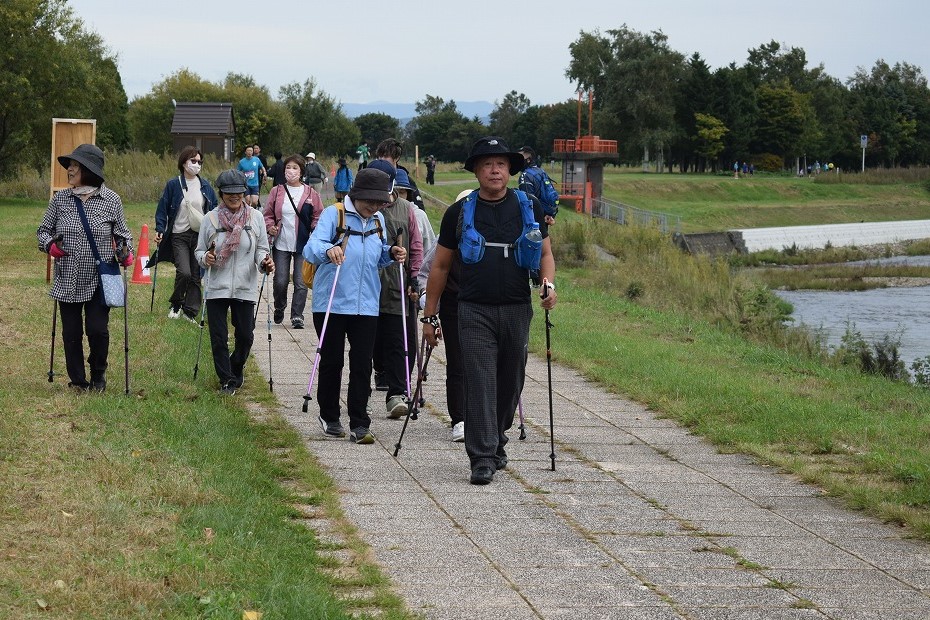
[459,302,533,468]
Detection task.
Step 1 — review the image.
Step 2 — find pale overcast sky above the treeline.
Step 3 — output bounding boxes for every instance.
[69,0,930,104]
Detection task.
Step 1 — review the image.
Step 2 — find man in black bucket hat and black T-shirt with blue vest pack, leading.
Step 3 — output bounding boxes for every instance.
[421,136,556,484]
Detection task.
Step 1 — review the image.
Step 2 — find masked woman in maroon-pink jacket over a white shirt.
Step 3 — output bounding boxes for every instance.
[264,155,323,329]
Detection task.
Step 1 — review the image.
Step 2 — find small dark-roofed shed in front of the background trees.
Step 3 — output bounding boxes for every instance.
[171,101,236,161]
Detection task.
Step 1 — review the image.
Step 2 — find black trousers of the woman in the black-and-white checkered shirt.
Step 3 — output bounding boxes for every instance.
[58,286,110,387]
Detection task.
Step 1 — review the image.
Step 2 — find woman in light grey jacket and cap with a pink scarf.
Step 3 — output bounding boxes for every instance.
[194,170,274,395]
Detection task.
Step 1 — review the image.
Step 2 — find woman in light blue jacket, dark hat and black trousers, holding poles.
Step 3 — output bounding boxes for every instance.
[304,168,407,444]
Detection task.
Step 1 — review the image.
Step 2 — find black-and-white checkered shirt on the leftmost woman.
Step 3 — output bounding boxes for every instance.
[36,185,132,303]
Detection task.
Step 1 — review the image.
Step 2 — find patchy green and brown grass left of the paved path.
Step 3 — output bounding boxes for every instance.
[0,200,409,620]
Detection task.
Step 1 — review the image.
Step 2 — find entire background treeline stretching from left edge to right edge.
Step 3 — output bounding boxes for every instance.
[7,0,930,178]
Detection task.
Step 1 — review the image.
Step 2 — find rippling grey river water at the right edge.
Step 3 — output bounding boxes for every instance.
[776,256,930,370]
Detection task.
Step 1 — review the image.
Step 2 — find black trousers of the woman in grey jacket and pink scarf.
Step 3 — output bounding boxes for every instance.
[207,298,255,386]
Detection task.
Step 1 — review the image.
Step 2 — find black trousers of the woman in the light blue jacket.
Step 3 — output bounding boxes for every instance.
[313,312,378,429]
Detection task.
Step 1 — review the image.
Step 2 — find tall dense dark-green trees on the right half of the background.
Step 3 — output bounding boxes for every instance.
[565,25,930,170]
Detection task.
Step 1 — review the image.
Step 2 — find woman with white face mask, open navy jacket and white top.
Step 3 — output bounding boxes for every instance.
[155,146,216,323]
